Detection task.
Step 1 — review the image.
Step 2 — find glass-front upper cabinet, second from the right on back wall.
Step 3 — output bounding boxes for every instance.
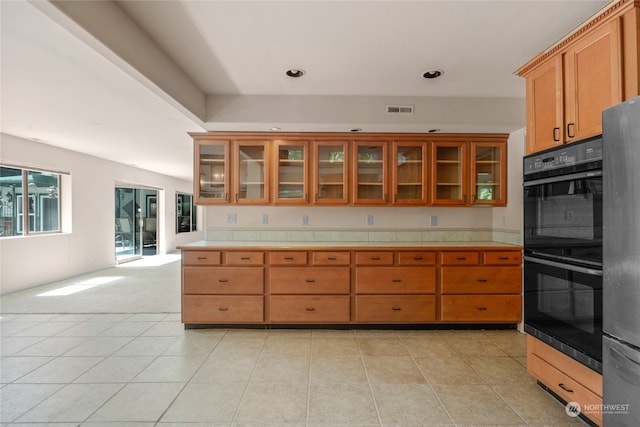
[431,142,468,206]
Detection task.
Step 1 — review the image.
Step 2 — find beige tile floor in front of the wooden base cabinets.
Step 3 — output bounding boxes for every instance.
[0,260,584,427]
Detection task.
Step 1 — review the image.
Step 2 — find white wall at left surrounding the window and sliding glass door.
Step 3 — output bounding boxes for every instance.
[0,134,204,294]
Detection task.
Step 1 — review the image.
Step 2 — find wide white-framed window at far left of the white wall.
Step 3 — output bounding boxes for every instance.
[0,166,60,237]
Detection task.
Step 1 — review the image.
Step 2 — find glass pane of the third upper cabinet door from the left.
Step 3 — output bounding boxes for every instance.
[276,144,307,201]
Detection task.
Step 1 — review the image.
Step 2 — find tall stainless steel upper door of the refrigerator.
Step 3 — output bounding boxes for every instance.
[602,97,640,347]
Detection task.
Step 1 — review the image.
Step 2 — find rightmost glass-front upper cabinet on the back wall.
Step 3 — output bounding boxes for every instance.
[471,142,507,206]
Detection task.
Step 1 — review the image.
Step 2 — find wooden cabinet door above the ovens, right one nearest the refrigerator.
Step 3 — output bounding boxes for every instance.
[564,20,622,142]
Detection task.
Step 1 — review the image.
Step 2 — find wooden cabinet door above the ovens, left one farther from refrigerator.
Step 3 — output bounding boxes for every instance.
[527,55,564,154]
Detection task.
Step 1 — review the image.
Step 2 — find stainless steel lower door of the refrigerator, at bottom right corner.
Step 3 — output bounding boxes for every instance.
[602,336,640,427]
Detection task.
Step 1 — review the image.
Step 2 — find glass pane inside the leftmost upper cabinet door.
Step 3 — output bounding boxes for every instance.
[198,144,228,201]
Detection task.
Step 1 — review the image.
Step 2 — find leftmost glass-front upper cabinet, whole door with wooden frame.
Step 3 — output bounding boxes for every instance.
[194,139,230,205]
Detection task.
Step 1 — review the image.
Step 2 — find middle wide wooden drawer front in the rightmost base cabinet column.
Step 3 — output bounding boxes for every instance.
[441,267,522,294]
